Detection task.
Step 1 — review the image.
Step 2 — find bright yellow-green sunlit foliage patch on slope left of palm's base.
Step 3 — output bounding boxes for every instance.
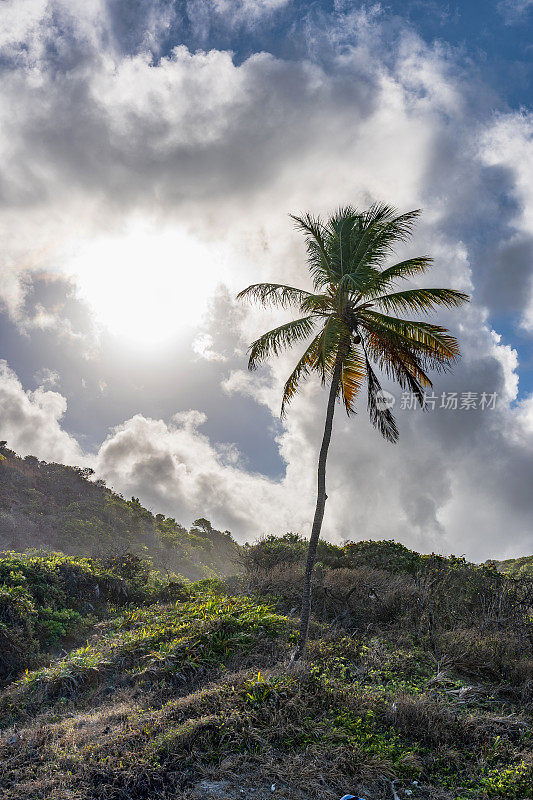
[5,582,287,714]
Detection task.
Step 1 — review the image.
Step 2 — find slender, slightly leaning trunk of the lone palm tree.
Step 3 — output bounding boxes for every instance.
[297,352,342,658]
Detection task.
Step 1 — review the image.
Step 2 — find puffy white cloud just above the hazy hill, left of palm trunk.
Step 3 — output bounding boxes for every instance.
[96,410,307,541]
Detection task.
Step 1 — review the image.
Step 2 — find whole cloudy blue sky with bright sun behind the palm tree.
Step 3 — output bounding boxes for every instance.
[0,0,533,561]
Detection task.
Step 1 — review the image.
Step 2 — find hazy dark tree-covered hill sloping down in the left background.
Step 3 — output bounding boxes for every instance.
[0,442,239,579]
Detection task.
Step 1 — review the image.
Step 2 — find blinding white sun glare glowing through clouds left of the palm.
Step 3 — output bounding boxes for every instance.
[67,227,220,346]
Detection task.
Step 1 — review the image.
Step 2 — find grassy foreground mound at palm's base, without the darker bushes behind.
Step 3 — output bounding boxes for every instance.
[0,586,533,800]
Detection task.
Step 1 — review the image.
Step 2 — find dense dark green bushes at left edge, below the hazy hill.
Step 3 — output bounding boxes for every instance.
[0,552,186,680]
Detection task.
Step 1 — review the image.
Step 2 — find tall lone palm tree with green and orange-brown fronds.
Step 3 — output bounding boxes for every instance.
[238,204,469,656]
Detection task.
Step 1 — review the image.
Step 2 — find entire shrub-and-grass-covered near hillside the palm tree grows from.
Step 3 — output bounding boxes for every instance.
[0,535,533,800]
